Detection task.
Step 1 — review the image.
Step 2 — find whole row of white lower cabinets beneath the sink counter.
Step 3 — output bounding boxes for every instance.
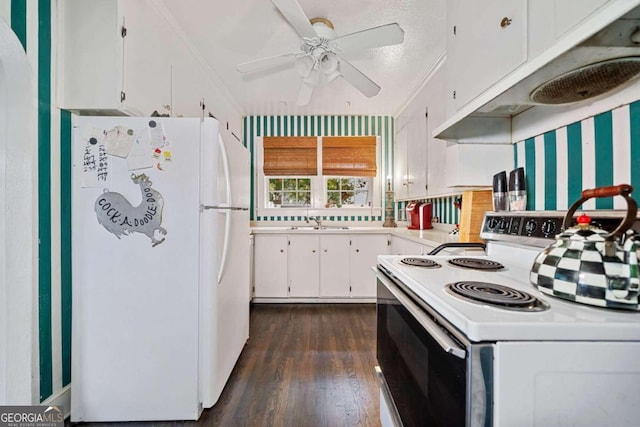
[253,234,389,299]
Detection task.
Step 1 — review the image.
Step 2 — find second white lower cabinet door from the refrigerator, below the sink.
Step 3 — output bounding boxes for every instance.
[287,234,320,298]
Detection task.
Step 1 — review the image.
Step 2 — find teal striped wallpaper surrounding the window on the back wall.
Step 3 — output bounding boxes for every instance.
[242,115,395,222]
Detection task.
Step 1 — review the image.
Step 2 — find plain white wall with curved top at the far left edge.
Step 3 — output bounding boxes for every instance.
[0,12,37,405]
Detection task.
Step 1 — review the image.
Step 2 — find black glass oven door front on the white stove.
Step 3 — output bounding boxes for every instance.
[377,281,467,427]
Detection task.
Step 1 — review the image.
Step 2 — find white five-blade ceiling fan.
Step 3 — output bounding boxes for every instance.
[236,0,404,105]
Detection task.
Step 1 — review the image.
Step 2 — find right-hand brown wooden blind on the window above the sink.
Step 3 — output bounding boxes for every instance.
[322,136,377,176]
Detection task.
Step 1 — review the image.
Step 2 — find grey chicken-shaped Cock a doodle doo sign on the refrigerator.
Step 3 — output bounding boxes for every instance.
[93,174,167,246]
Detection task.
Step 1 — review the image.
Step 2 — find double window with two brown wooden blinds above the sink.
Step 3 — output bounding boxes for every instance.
[259,136,382,211]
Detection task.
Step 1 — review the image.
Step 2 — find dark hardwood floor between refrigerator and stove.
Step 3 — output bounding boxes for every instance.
[74,304,380,427]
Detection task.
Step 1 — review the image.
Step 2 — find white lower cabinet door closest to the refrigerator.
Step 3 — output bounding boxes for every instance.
[253,234,288,298]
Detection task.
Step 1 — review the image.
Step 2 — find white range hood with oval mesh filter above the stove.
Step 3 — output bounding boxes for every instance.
[434,6,640,142]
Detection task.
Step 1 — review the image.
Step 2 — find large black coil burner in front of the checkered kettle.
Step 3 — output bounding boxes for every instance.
[445,281,549,311]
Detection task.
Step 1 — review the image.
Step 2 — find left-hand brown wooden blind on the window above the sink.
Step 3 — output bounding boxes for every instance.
[263,136,318,176]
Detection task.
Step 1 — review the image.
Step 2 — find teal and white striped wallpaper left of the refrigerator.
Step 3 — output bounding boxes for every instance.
[10,0,71,402]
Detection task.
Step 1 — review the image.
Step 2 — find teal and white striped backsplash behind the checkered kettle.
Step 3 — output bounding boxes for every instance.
[507,97,640,210]
